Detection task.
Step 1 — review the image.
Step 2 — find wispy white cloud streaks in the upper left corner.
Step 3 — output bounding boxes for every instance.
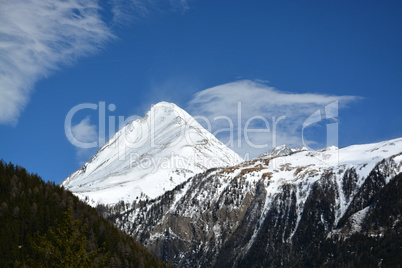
[0,0,187,124]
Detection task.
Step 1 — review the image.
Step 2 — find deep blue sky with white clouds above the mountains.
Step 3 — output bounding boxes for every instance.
[0,0,402,183]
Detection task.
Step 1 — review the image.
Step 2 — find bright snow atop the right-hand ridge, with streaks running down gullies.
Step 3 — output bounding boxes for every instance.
[251,138,402,230]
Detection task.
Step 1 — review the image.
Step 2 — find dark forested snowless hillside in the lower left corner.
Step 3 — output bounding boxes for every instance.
[0,161,167,267]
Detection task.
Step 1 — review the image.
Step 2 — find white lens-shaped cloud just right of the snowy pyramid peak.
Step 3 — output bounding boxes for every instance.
[188,80,359,158]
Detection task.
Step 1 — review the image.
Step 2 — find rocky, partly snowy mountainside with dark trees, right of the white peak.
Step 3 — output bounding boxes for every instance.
[105,138,402,267]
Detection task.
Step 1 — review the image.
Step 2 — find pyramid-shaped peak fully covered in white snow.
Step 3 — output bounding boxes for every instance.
[62,102,243,205]
